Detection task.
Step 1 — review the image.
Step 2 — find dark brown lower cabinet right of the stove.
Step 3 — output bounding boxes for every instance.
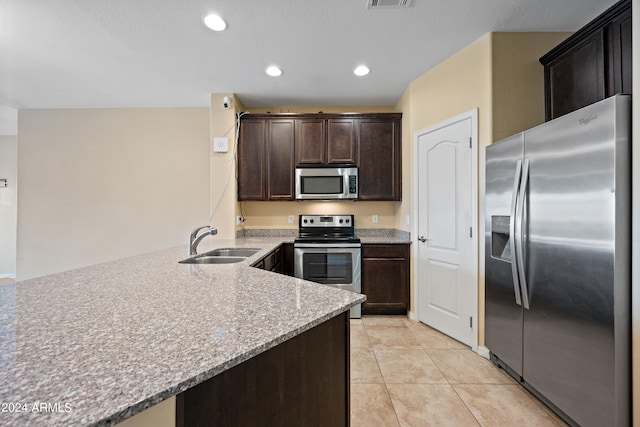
[362,244,409,314]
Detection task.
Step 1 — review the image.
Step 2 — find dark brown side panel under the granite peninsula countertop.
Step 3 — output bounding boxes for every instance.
[176,312,349,427]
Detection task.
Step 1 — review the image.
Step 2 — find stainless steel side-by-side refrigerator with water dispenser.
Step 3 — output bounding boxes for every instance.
[485,95,631,426]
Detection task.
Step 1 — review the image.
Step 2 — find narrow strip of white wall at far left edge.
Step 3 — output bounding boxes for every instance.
[0,136,18,278]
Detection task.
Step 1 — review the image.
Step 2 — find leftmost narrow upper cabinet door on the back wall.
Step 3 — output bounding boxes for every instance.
[238,119,267,200]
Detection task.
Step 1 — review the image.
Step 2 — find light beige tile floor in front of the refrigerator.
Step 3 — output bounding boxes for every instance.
[351,316,566,427]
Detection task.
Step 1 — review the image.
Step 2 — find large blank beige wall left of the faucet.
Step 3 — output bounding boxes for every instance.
[17,108,209,280]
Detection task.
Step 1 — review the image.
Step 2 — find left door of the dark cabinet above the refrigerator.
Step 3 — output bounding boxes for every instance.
[545,30,605,120]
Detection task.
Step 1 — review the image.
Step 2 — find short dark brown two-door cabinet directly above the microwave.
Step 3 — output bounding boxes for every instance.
[296,118,356,165]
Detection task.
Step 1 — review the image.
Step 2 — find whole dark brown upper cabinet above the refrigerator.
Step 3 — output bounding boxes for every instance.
[540,0,632,120]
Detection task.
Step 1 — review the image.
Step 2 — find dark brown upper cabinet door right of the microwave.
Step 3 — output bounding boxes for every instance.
[357,119,402,200]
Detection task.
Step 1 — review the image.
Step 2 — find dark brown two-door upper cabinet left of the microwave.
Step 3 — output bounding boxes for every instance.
[238,118,295,200]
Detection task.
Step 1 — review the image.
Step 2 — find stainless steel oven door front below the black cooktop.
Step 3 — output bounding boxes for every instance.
[293,243,362,317]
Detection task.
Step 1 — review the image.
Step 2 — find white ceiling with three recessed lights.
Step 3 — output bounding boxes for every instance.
[0,0,616,134]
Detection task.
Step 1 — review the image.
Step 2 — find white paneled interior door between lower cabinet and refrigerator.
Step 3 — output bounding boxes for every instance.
[414,110,478,350]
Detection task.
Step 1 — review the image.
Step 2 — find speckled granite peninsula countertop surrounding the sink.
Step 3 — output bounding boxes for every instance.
[0,237,364,426]
